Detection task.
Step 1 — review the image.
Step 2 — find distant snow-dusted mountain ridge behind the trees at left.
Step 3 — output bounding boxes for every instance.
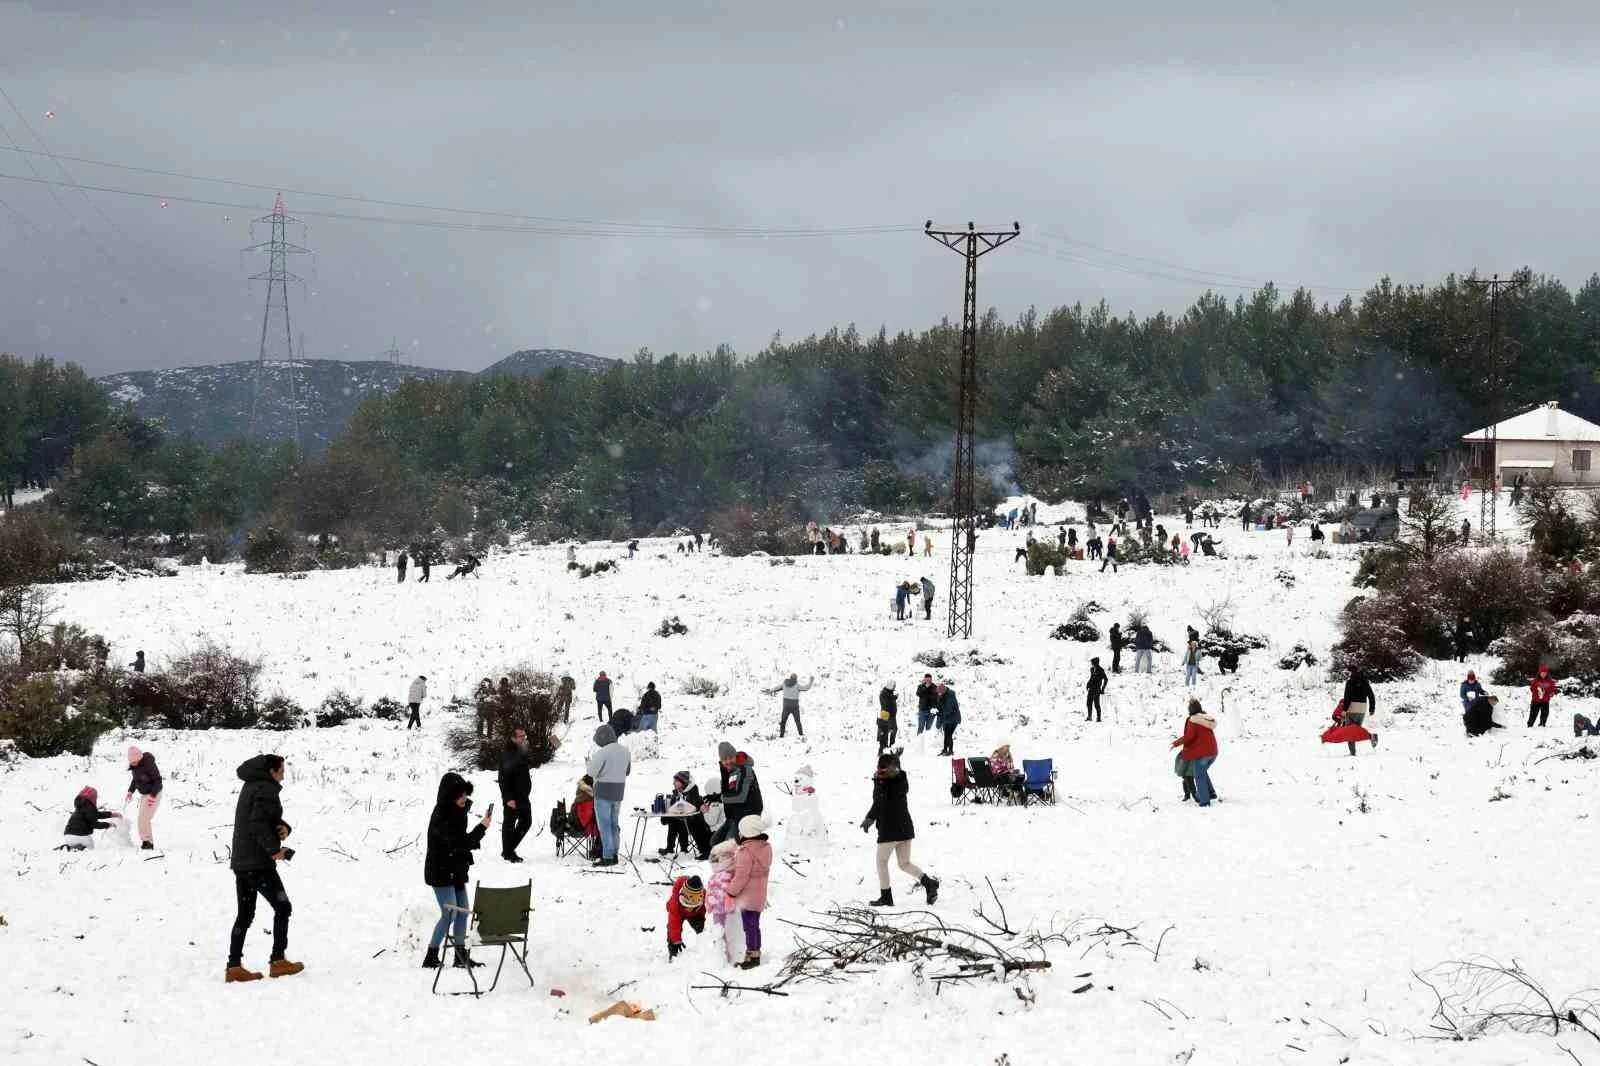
[98,347,614,451]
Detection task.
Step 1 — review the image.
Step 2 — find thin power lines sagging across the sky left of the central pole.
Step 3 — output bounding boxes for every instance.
[0,144,915,237]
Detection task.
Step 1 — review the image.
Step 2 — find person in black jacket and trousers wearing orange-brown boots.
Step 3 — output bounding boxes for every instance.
[222,755,306,983]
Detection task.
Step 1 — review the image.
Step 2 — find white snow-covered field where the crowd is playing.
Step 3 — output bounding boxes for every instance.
[0,504,1600,1066]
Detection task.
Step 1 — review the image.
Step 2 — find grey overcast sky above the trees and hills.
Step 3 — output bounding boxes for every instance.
[0,0,1600,373]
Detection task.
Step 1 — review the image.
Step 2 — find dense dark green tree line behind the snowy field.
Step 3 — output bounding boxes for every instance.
[9,271,1600,563]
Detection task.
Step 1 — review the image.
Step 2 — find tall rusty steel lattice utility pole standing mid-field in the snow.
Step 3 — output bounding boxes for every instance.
[923,221,1022,637]
